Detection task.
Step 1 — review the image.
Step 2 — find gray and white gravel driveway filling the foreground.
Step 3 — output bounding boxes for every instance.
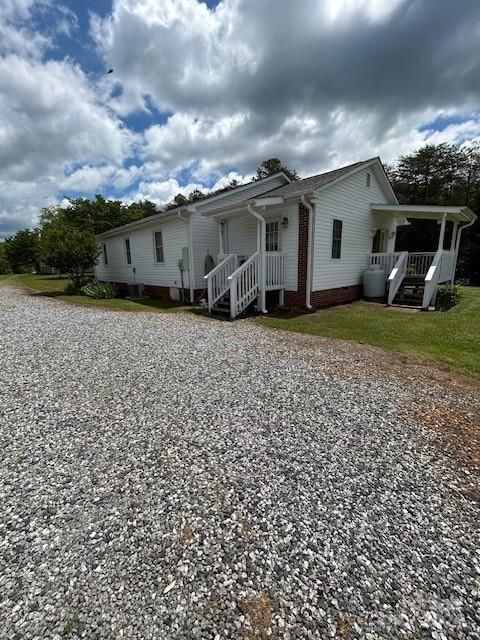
[0,287,480,640]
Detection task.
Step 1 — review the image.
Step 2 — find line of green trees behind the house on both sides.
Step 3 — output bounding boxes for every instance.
[0,150,480,285]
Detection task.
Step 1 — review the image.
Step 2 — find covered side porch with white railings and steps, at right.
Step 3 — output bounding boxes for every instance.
[369,204,476,310]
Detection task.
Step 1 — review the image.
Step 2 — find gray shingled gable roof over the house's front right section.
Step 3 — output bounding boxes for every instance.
[256,157,397,203]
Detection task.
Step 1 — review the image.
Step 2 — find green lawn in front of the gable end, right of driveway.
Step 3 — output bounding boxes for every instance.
[261,287,480,376]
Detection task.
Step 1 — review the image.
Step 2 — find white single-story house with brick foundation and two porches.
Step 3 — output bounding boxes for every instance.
[96,158,476,318]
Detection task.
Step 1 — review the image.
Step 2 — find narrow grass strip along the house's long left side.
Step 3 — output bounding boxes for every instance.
[0,273,192,313]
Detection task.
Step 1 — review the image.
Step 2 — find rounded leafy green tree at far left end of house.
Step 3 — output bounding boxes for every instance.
[40,221,100,288]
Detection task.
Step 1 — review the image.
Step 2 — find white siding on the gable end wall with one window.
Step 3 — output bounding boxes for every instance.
[313,168,394,291]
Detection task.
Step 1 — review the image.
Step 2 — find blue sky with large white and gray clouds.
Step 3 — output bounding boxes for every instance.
[0,0,480,238]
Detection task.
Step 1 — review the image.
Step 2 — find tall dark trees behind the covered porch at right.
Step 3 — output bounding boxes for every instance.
[387,143,480,284]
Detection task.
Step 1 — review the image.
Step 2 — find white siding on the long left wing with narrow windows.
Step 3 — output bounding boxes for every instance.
[95,219,188,287]
